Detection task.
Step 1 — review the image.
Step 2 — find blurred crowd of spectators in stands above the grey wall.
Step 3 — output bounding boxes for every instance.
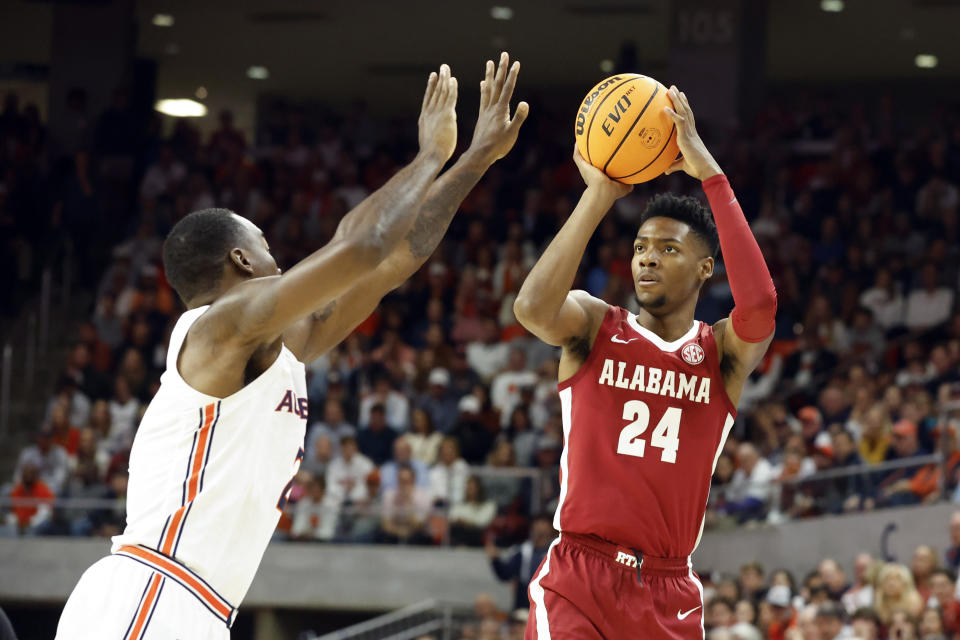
[0,82,960,545]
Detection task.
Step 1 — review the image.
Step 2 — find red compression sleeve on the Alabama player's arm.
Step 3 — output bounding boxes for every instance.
[703,174,777,342]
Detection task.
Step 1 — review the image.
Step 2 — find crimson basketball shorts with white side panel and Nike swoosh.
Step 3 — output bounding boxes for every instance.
[524,533,704,640]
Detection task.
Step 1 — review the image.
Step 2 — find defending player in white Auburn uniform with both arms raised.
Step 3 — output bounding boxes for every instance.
[57,54,528,640]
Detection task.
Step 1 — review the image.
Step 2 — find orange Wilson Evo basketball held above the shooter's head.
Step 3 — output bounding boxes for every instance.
[574,73,680,184]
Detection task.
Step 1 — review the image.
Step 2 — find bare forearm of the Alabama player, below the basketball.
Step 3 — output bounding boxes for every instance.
[517,189,614,318]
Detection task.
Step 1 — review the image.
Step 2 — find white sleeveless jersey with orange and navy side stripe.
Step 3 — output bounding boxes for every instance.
[112,306,307,607]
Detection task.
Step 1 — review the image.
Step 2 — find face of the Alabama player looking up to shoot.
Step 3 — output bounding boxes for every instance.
[630,217,713,315]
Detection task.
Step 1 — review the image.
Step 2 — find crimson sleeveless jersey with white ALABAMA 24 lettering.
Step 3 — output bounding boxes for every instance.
[554,306,736,558]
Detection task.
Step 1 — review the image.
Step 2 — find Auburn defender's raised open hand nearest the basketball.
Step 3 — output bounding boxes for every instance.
[470,52,530,164]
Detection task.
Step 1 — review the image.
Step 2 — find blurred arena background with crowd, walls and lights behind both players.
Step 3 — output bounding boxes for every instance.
[0,0,960,640]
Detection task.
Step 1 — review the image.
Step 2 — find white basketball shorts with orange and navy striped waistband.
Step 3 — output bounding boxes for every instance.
[56,547,236,640]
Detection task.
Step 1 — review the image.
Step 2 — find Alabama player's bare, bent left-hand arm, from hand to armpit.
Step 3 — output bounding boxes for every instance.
[513,150,632,380]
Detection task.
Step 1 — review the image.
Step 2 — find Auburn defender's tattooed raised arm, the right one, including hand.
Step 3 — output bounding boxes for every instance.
[283,53,529,362]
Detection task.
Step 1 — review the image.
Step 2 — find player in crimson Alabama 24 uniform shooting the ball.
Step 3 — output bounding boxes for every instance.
[514,87,776,640]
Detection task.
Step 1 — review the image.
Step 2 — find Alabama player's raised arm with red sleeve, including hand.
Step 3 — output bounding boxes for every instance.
[665,87,777,402]
